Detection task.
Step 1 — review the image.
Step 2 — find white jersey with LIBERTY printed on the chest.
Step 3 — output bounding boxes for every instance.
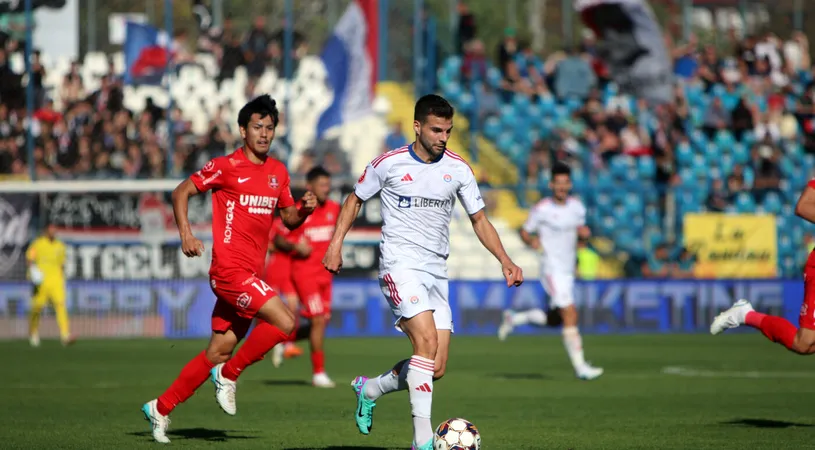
[354,144,484,278]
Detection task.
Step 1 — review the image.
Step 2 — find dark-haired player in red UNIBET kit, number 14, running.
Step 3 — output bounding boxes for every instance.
[142,95,317,443]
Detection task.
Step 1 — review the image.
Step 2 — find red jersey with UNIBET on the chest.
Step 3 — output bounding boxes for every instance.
[190,148,294,278]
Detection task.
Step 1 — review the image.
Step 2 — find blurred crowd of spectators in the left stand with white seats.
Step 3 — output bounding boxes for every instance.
[0,17,326,179]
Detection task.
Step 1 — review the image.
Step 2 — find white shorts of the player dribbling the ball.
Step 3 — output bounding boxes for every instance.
[379,269,453,331]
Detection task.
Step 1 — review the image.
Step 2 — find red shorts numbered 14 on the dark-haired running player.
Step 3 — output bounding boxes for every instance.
[209,272,277,339]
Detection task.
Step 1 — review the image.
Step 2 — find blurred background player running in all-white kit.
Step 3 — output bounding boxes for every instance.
[498,162,603,380]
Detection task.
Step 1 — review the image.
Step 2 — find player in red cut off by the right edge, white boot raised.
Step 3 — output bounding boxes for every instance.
[710,180,815,355]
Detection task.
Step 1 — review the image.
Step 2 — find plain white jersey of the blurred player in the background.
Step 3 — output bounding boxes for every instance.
[524,197,586,275]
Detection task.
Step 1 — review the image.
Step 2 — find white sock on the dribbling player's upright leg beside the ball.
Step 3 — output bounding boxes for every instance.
[406,355,435,445]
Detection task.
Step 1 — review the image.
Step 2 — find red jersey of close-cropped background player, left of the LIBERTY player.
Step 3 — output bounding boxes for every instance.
[289,200,340,279]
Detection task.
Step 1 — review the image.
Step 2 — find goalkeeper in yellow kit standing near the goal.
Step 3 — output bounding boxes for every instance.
[26,225,73,347]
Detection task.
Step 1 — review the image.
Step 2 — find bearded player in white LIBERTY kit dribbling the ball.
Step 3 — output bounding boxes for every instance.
[323,95,523,450]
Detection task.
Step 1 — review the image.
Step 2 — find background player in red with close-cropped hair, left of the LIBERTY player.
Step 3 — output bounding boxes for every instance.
[272,166,340,388]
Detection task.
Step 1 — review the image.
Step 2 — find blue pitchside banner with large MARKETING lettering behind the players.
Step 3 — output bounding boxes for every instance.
[0,279,812,339]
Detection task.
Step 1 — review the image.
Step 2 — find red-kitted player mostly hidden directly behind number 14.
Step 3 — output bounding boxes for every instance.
[265,217,311,367]
